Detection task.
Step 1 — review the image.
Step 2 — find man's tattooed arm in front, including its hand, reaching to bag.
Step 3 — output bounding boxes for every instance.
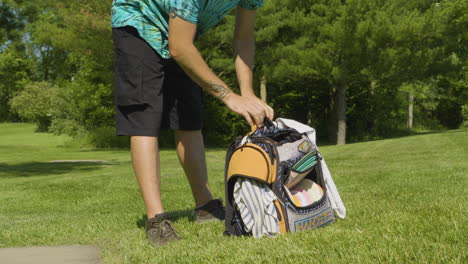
[169,10,265,126]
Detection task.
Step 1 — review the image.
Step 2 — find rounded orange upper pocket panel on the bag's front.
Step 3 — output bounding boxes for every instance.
[227,143,276,183]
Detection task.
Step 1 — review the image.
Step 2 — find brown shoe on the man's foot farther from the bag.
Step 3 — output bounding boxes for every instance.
[145,213,180,247]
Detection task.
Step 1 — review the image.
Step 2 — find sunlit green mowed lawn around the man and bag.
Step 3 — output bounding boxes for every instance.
[0,124,468,264]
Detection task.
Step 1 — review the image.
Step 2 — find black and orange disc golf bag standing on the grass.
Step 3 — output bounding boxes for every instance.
[224,119,345,237]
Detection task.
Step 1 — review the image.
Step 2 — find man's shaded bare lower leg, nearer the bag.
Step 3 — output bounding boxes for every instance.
[175,130,213,206]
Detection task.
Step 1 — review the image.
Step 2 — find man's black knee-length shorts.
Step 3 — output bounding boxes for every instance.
[112,27,202,136]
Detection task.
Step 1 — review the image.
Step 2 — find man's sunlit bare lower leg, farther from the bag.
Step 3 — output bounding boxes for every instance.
[130,136,164,218]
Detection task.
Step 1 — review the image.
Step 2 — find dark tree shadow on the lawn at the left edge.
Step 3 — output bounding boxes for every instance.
[0,162,109,179]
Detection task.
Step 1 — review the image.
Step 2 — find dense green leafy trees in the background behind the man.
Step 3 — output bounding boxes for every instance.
[0,0,468,145]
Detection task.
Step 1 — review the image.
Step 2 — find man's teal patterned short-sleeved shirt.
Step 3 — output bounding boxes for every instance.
[112,0,263,59]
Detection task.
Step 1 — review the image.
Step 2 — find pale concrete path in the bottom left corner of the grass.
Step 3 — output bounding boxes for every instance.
[0,246,101,264]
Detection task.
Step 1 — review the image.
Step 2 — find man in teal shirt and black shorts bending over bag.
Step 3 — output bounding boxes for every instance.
[112,0,273,246]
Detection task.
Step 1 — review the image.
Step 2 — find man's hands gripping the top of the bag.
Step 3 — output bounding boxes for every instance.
[222,93,274,127]
